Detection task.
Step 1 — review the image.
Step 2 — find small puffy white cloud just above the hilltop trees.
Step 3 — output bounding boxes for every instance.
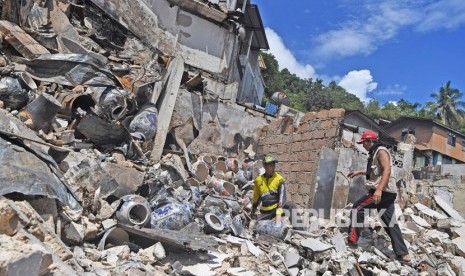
[338,70,378,102]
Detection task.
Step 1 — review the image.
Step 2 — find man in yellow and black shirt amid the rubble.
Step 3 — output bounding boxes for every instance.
[251,155,295,223]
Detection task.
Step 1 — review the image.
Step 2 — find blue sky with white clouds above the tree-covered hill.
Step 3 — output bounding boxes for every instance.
[252,0,465,103]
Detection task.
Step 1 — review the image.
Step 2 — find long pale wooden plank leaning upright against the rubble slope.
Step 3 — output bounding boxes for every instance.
[150,57,184,161]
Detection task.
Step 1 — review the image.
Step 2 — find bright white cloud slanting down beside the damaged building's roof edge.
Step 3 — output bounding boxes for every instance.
[265,28,315,79]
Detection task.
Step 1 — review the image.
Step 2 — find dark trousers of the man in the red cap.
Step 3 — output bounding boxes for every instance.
[349,190,408,256]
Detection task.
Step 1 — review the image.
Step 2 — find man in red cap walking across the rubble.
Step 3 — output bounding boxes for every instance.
[348,130,410,262]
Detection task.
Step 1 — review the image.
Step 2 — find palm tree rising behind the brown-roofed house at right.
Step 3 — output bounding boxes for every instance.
[425,81,465,126]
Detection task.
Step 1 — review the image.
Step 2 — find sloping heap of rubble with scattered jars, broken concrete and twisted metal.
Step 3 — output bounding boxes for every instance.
[0,1,465,276]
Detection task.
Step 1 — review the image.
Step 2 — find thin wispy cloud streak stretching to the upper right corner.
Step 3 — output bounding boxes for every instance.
[313,0,465,59]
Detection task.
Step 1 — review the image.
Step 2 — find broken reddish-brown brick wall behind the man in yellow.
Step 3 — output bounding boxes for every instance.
[257,109,344,207]
